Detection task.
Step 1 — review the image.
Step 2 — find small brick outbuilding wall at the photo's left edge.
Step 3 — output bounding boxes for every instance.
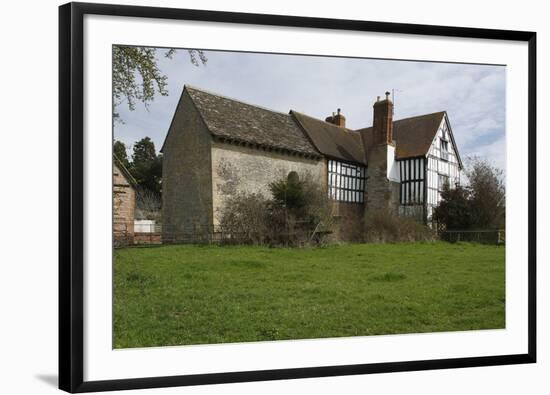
[113,163,136,246]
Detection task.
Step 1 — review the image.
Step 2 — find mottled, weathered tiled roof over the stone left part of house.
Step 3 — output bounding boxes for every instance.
[184,85,320,157]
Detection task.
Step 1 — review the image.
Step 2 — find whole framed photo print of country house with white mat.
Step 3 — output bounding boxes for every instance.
[59,3,536,392]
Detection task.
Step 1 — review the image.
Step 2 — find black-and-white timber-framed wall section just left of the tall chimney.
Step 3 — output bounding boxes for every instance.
[328,160,366,203]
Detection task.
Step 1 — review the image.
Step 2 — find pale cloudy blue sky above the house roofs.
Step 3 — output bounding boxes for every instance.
[114,49,506,170]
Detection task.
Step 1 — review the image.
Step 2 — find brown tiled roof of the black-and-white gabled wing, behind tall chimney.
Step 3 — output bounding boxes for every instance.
[358,111,445,159]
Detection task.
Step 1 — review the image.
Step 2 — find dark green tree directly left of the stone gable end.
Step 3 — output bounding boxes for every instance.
[130,137,162,195]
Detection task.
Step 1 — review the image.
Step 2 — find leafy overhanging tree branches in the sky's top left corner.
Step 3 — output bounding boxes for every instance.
[113,45,208,120]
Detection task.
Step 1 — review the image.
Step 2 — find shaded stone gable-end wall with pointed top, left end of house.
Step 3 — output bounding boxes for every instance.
[162,93,212,243]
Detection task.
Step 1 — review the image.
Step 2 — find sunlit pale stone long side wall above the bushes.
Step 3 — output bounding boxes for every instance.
[211,142,327,225]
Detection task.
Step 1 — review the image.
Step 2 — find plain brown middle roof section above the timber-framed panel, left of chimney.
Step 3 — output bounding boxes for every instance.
[290,110,367,164]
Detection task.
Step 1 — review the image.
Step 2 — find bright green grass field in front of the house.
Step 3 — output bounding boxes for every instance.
[114,242,505,348]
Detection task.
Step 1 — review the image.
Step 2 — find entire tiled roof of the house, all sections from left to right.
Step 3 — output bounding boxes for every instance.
[181,85,452,164]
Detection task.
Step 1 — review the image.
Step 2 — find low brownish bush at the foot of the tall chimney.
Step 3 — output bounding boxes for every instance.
[365,210,436,243]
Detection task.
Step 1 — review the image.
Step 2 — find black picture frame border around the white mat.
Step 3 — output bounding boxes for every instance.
[59,3,536,392]
